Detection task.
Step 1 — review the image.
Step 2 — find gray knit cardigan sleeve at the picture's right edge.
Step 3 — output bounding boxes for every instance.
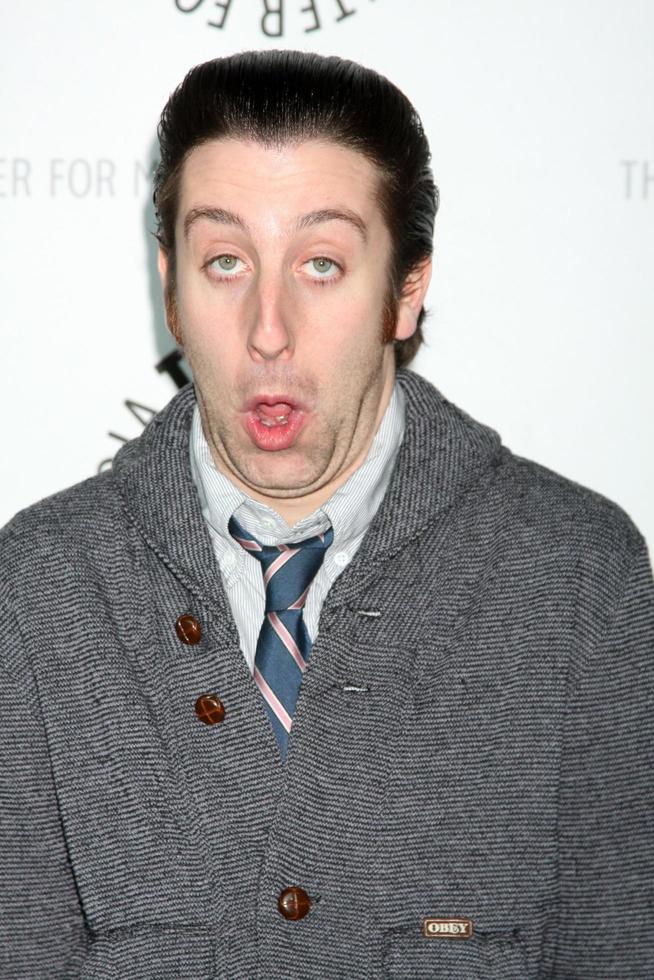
[553,536,654,980]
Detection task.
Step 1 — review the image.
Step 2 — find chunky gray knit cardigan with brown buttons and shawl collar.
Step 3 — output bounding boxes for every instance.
[0,371,654,980]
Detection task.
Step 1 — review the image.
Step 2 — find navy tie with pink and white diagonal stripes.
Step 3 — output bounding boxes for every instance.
[229,517,334,760]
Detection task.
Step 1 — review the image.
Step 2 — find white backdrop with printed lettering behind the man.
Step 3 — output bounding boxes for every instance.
[0,0,654,542]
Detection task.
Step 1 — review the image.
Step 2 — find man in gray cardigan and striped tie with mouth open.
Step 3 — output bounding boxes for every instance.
[0,51,654,980]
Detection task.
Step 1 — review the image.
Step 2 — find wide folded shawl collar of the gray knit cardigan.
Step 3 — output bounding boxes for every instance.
[113,370,501,608]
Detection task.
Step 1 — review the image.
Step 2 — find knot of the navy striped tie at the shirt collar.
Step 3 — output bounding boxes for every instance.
[228,517,334,613]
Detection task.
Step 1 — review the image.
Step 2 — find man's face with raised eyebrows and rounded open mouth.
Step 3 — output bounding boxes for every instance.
[160,140,426,500]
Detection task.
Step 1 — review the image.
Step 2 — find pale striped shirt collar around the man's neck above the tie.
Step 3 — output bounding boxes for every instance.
[190,383,405,550]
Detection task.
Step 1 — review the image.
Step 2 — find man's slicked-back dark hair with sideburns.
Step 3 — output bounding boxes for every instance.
[154,50,438,367]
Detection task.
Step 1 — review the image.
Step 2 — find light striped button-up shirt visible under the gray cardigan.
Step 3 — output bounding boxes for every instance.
[190,383,405,671]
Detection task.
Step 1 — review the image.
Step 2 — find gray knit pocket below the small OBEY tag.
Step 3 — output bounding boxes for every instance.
[382,930,530,980]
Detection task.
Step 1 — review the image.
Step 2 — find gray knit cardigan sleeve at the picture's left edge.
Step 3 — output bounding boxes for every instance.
[0,584,87,980]
